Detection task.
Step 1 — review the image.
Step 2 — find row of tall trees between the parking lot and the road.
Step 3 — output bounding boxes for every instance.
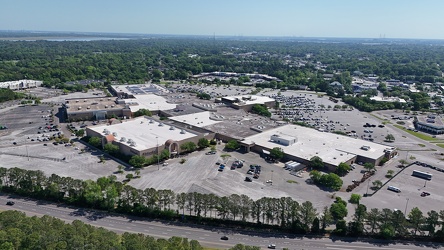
[0,168,444,241]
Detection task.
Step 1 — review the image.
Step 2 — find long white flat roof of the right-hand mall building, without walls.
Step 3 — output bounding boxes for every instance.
[243,125,388,166]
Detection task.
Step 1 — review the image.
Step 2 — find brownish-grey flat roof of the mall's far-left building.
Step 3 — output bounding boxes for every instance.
[66,97,125,113]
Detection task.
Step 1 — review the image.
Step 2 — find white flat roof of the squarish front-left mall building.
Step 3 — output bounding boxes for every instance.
[88,117,197,151]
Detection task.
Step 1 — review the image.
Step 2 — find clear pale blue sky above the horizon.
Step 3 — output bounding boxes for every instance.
[0,0,444,39]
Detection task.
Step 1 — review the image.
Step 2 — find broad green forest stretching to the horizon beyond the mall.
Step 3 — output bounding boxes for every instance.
[0,38,444,88]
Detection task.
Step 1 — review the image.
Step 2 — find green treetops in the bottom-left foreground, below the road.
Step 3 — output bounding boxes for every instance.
[0,210,203,250]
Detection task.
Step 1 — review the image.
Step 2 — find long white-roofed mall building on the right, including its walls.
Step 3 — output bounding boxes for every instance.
[240,125,396,170]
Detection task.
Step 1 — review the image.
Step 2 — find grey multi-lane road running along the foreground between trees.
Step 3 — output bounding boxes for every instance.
[0,194,442,250]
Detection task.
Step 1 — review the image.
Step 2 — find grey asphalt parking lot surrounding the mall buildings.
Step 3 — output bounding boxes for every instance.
[0,86,444,216]
